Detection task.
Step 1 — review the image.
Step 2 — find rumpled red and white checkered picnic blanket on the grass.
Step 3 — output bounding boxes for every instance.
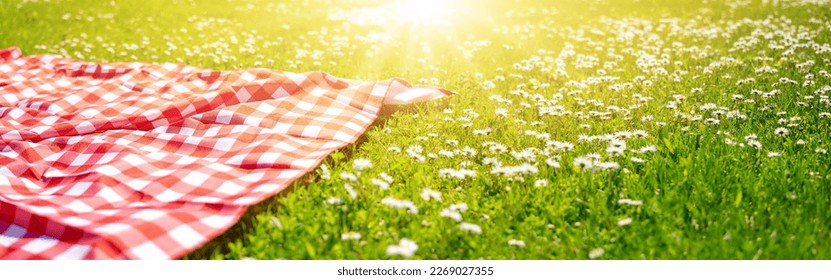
[0,48,449,259]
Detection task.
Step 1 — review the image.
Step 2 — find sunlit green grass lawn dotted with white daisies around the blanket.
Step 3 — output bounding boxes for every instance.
[0,0,831,259]
